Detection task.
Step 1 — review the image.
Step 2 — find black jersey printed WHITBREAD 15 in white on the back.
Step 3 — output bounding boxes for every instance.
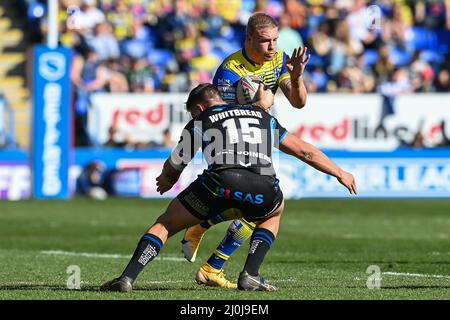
[171,104,287,175]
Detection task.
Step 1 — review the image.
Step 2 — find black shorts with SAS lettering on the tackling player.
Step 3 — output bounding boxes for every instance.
[177,168,283,221]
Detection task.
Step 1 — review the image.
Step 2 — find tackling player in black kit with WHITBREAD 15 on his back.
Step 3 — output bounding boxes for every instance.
[101,84,356,292]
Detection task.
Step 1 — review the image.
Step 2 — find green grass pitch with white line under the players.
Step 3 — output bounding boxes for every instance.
[0,198,450,300]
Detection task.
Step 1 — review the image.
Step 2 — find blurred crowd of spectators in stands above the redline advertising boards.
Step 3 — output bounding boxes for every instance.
[24,0,450,148]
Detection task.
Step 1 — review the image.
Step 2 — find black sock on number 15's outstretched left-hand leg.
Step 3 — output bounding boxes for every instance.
[122,234,163,283]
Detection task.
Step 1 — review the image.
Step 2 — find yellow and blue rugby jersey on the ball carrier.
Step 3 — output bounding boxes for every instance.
[213,49,289,103]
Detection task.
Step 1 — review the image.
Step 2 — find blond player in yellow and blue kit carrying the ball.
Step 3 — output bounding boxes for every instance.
[182,13,310,289]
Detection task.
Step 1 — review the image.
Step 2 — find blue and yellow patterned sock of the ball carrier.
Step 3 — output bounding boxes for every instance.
[207,219,255,270]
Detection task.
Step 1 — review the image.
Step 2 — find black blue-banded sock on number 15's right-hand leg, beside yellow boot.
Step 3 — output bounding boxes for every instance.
[244,228,275,276]
